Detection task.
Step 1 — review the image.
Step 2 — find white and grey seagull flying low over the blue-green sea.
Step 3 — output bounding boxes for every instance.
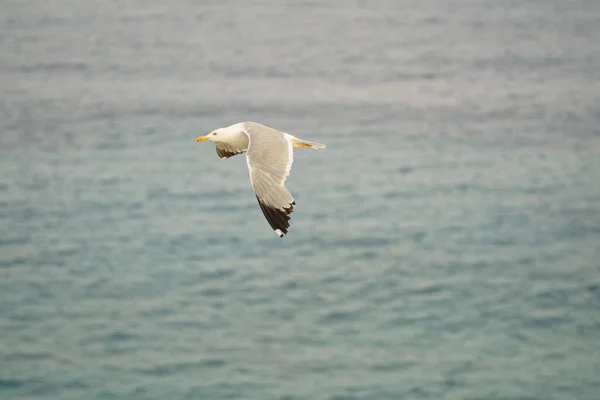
[196,122,325,237]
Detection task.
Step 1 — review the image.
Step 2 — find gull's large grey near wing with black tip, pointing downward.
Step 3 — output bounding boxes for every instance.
[245,124,296,237]
